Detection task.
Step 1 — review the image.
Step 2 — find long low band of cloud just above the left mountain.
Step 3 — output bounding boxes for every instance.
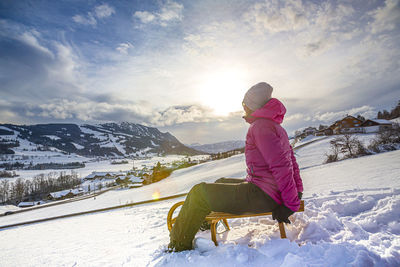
[4,96,214,127]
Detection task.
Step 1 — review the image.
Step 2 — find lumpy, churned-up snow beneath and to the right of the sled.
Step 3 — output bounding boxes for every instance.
[149,190,400,266]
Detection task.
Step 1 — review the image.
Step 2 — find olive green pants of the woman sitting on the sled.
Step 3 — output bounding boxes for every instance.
[169,178,278,251]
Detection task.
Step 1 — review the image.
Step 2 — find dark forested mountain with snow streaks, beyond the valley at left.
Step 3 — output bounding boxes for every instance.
[0,122,201,157]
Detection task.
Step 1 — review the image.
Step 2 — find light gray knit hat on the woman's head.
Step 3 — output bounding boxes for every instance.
[243,82,272,111]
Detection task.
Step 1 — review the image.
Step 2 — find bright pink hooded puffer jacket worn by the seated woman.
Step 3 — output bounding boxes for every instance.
[245,98,303,211]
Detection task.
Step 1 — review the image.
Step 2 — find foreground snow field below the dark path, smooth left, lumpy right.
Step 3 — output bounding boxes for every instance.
[0,190,400,266]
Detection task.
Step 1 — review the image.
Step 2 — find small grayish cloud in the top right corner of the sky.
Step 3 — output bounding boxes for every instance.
[370,0,400,33]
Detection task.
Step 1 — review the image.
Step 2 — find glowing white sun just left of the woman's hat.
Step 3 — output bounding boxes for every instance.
[199,68,248,116]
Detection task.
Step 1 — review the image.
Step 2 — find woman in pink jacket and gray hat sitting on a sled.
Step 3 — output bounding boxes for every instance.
[168,82,303,251]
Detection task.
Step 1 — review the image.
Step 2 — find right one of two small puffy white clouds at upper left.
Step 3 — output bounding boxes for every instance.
[133,0,183,27]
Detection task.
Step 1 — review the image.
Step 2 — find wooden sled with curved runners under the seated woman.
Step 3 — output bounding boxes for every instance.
[167,200,304,246]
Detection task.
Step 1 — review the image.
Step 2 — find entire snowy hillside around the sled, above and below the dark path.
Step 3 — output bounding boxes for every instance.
[0,135,400,266]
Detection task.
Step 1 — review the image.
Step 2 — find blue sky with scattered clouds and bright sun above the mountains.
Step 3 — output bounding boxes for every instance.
[0,0,400,144]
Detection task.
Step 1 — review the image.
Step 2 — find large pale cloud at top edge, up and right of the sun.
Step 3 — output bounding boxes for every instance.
[242,0,361,57]
